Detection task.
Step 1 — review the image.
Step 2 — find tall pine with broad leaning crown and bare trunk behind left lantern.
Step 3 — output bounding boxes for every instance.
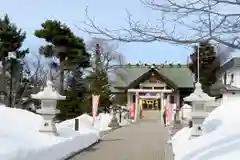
[35,20,90,92]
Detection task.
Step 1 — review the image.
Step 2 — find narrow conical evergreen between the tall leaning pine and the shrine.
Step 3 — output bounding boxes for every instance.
[87,44,111,112]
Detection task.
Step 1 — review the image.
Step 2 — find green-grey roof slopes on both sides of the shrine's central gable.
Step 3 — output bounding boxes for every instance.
[113,65,193,88]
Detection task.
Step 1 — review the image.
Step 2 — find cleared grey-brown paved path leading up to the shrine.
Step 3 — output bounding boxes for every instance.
[66,111,173,160]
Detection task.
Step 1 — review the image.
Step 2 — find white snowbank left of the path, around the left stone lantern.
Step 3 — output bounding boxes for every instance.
[0,105,128,160]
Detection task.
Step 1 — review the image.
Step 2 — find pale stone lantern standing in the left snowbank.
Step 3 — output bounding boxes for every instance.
[31,81,66,135]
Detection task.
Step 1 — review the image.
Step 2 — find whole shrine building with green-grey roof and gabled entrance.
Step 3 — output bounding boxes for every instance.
[111,64,193,120]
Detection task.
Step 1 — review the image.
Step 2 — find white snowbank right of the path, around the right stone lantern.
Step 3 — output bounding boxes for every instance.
[172,100,240,160]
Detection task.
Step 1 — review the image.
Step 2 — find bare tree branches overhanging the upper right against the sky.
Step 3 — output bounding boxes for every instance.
[79,0,240,49]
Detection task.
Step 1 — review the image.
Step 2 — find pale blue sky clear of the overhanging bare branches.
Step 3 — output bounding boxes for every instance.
[0,0,192,63]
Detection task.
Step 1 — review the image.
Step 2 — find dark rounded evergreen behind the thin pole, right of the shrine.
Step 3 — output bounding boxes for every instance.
[189,41,220,94]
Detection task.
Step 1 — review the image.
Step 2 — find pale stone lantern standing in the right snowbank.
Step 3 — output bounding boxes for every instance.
[183,82,214,137]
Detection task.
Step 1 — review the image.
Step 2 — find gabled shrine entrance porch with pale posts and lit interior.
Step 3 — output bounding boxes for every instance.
[124,68,180,121]
